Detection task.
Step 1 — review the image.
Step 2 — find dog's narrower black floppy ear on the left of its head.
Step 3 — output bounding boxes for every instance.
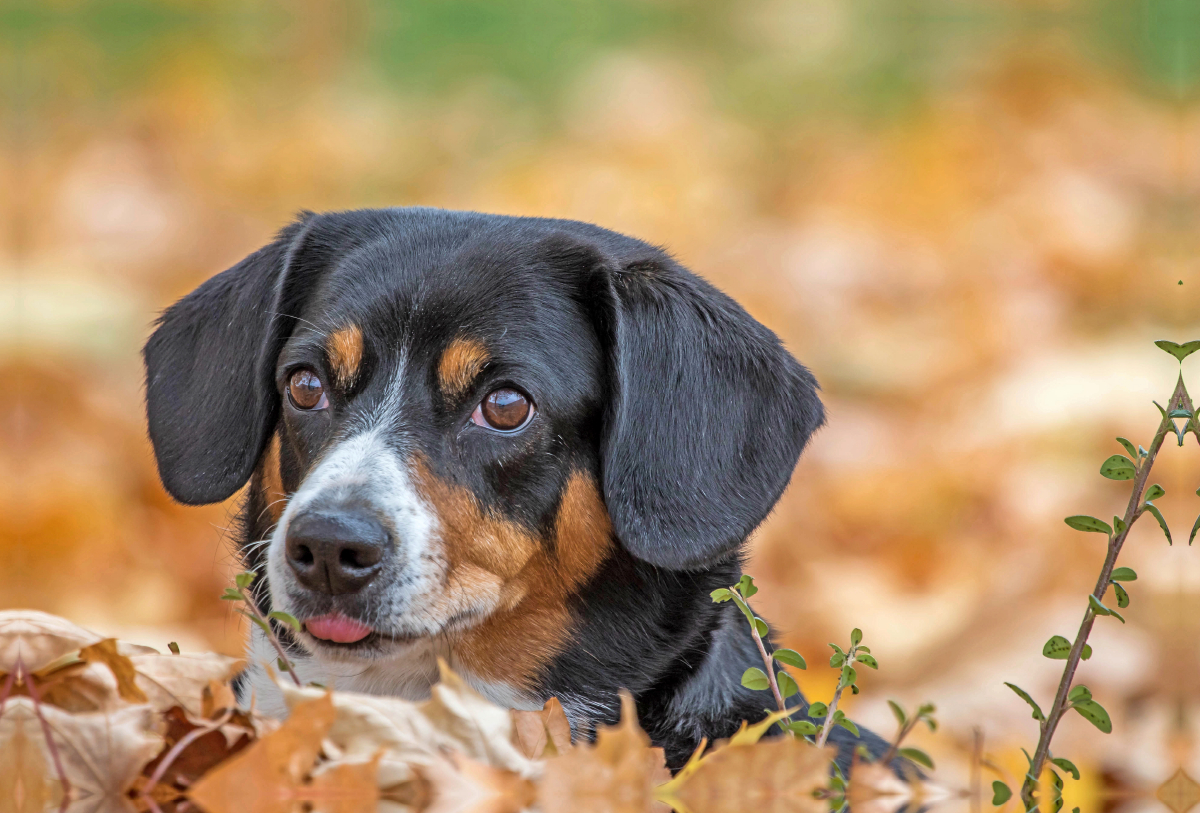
[143,215,321,505]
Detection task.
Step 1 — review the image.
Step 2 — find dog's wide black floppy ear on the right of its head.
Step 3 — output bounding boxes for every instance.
[557,236,824,570]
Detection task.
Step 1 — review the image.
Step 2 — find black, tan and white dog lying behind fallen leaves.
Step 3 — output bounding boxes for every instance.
[144,207,886,770]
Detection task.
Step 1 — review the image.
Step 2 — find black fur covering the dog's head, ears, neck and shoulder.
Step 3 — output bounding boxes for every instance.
[145,209,884,767]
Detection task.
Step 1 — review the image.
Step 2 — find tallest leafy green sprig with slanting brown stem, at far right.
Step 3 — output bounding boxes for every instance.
[992,341,1200,811]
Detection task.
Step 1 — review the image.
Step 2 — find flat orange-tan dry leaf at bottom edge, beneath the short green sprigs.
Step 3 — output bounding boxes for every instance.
[659,736,836,813]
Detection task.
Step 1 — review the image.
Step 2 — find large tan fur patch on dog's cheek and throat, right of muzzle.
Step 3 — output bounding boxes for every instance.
[416,463,612,689]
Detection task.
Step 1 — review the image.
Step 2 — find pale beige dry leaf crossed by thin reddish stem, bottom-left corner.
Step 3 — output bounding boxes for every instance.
[13,698,163,813]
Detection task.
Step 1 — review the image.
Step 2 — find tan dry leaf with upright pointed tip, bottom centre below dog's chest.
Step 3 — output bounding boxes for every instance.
[538,692,672,813]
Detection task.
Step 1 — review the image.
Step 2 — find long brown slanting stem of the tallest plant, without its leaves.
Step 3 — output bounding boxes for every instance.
[1021,375,1200,809]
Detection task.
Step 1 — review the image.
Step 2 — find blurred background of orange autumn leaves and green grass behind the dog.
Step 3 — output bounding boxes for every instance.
[0,0,1200,811]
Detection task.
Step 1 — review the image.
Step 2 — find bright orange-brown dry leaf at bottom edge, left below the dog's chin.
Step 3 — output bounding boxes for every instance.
[187,692,379,813]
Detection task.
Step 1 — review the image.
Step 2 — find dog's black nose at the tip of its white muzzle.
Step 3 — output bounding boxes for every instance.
[287,508,390,596]
